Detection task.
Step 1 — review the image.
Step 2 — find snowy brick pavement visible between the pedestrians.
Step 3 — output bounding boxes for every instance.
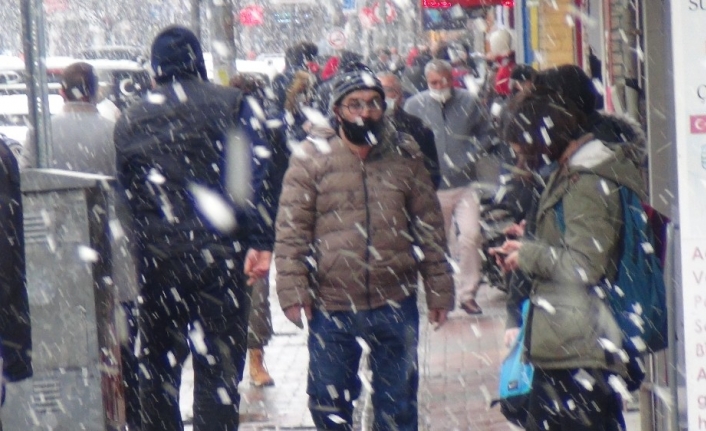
[182,288,639,431]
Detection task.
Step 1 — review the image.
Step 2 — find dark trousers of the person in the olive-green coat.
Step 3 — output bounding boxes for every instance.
[525,368,625,431]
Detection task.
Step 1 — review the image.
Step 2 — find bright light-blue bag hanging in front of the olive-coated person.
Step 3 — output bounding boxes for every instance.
[490,299,534,427]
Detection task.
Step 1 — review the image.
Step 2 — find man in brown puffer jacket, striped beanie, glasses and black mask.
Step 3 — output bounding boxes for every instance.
[275,64,454,431]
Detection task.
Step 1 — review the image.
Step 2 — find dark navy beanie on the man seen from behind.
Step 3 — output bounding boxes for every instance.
[151,25,208,84]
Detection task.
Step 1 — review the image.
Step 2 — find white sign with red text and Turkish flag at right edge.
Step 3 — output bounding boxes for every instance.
[671,0,706,431]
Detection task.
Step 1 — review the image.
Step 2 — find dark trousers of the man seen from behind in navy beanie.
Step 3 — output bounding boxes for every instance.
[138,255,250,431]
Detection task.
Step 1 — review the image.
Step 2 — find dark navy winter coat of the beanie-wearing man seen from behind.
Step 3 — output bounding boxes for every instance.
[115,79,274,258]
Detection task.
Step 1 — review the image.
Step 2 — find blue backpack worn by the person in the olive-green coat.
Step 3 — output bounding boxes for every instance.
[554,186,667,391]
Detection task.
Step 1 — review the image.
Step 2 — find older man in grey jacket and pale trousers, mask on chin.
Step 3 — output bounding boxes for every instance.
[404,60,490,314]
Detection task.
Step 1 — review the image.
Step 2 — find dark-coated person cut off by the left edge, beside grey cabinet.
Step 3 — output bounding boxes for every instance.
[0,134,32,388]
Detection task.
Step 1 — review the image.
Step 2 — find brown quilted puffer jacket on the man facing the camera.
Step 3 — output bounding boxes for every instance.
[275,121,453,311]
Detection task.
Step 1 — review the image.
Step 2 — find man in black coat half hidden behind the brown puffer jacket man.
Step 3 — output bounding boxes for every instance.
[378,72,441,189]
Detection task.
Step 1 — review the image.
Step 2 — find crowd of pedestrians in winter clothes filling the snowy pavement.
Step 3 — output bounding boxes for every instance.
[0,22,644,431]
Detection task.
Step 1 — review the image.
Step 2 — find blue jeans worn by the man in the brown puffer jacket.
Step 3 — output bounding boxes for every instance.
[307,296,419,431]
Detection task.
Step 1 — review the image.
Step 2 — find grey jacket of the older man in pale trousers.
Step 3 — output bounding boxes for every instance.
[404,88,491,190]
